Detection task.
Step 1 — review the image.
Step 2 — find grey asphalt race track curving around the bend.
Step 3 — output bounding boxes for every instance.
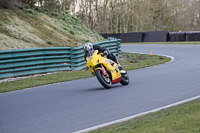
[0,45,200,133]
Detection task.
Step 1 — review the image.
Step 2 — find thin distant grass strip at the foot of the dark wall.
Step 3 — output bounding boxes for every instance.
[123,41,200,44]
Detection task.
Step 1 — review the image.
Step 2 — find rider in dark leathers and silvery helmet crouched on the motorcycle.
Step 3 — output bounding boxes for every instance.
[83,42,123,70]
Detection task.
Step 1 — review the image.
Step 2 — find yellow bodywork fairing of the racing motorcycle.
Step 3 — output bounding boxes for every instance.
[86,50,121,80]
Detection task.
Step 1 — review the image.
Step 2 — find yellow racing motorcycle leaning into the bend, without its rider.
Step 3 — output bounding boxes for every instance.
[86,50,129,89]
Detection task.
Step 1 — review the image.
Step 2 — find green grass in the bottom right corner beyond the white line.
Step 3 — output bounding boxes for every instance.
[90,99,200,133]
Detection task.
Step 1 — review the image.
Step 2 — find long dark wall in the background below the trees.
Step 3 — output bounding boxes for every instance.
[101,31,200,43]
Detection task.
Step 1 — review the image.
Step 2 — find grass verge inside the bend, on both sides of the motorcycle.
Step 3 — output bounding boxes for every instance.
[0,53,171,93]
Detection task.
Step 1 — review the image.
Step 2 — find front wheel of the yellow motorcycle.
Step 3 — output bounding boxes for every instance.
[95,69,112,89]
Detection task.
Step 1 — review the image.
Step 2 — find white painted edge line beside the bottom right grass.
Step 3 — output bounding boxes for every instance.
[73,95,200,133]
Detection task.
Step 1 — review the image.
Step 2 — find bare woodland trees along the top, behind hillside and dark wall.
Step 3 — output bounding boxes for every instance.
[3,0,200,33]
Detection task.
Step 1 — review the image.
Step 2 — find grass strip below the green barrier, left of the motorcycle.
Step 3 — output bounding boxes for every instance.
[0,71,92,93]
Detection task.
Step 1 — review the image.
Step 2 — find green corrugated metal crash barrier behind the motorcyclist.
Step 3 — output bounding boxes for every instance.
[0,39,121,79]
